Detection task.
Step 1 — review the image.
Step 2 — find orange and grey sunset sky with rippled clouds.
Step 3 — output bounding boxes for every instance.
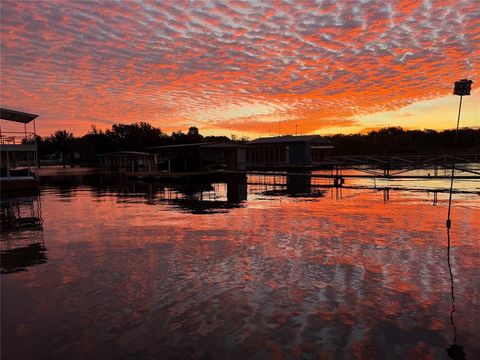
[0,0,480,138]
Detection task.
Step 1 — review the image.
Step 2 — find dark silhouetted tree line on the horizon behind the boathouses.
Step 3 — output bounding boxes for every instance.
[36,122,480,165]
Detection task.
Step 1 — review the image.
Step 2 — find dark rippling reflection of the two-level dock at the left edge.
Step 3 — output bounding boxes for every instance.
[0,196,47,274]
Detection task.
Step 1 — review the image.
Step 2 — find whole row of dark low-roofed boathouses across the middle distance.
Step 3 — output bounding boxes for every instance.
[97,135,333,173]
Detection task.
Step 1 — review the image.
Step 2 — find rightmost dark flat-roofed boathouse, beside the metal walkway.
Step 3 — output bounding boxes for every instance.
[247,135,333,168]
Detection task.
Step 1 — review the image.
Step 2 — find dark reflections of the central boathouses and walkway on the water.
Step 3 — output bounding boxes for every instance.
[97,171,479,213]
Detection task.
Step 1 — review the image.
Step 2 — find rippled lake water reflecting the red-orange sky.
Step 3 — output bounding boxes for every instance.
[1,174,480,360]
